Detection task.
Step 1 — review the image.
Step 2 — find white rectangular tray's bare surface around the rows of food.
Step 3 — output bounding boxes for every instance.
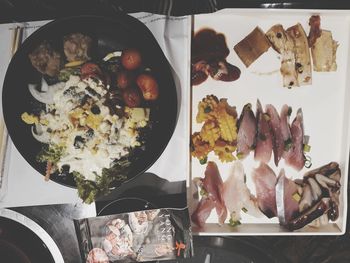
[188,9,349,235]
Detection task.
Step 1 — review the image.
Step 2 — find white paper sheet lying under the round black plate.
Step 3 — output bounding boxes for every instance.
[0,13,191,207]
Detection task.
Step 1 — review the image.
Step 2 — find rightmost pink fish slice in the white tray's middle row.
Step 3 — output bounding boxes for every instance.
[284,109,305,171]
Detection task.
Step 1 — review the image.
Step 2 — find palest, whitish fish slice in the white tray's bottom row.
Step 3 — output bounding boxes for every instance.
[224,161,262,221]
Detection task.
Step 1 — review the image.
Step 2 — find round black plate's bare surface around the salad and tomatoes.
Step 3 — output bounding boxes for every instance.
[3,14,177,204]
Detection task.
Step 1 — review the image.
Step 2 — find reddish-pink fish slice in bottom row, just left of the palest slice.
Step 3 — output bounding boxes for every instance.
[203,162,227,224]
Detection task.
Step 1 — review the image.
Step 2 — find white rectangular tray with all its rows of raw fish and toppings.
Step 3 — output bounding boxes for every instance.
[188,9,350,235]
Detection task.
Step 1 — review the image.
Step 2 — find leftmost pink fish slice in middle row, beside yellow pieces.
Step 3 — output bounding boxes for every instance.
[237,103,257,159]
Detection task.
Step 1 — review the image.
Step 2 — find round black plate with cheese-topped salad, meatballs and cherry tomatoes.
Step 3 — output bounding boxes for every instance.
[3,14,177,203]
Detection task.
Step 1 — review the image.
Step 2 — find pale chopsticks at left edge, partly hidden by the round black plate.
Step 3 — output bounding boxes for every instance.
[0,26,24,199]
